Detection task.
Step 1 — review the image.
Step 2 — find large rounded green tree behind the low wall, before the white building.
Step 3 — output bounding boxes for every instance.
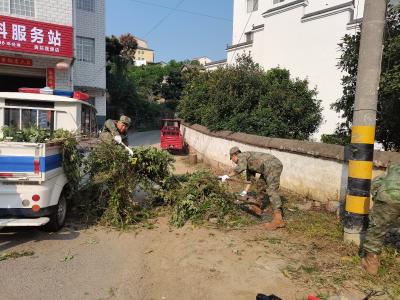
[178,56,322,139]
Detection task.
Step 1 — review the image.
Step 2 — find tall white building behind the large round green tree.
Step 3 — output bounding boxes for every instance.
[227,0,365,137]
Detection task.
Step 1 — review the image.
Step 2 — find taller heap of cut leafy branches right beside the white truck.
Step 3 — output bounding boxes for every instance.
[81,142,173,228]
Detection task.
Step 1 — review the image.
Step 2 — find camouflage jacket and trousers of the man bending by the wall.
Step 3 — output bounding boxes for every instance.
[234,152,283,210]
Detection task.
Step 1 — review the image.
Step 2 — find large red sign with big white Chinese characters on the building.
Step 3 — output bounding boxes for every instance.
[0,15,73,57]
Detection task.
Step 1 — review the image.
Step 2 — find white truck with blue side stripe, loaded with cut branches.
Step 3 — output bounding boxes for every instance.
[0,93,97,231]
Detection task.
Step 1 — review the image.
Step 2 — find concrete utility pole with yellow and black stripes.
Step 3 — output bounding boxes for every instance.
[344,0,387,244]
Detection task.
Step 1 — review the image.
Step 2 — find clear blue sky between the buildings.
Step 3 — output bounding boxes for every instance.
[106,0,233,62]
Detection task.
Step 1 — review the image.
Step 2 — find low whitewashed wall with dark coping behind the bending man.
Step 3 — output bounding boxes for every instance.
[181,124,400,203]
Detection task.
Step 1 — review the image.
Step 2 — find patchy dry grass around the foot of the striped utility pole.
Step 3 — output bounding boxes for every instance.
[282,199,400,299]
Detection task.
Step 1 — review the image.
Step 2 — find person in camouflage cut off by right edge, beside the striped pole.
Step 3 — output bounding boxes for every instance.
[362,163,400,275]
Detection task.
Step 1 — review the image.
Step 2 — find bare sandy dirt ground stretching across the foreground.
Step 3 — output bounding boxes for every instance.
[0,218,306,299]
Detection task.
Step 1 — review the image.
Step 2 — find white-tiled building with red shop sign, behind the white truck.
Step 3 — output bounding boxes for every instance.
[0,0,106,125]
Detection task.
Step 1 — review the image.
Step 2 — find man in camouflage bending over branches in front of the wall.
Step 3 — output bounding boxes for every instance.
[222,147,285,230]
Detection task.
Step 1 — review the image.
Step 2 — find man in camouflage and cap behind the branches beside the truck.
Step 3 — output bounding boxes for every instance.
[100,116,131,146]
